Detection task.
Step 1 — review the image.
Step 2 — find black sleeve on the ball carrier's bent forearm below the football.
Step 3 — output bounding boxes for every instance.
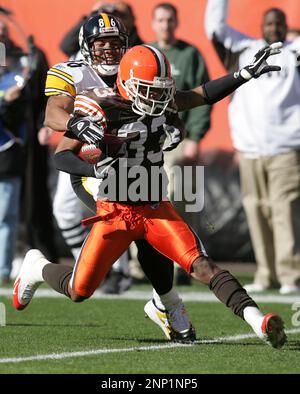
[54,150,95,177]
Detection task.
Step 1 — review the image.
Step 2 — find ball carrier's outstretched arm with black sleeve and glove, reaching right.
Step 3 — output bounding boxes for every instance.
[175,42,282,111]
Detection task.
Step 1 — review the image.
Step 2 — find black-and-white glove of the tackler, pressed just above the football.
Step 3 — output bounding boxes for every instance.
[67,116,104,144]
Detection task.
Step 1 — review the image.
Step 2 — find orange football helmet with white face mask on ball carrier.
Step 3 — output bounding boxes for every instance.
[117,45,175,116]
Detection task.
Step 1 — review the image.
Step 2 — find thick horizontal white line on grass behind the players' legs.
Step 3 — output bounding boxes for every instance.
[0,288,300,304]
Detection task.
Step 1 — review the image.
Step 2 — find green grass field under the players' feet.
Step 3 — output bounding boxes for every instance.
[0,276,300,374]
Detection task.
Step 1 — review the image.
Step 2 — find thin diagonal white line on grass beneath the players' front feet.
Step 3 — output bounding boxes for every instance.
[0,328,300,364]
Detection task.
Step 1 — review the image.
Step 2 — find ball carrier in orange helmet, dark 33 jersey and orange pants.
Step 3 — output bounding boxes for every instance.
[14,31,286,348]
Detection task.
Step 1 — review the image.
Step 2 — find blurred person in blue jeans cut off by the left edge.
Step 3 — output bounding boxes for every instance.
[0,21,26,284]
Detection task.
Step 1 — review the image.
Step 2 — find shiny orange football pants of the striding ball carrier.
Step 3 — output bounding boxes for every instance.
[71,201,206,297]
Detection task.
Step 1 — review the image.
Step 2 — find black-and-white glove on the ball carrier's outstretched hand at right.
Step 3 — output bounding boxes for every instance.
[239,42,282,80]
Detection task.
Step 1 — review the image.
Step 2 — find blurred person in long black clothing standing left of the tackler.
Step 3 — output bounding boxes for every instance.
[22,39,58,262]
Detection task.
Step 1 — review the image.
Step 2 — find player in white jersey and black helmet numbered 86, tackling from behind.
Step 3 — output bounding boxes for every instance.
[45,13,195,341]
